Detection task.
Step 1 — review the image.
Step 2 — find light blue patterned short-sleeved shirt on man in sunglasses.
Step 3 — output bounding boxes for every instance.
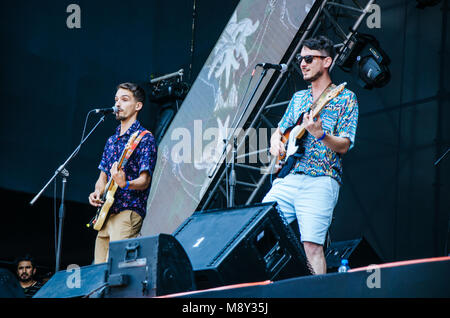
[278,87,358,184]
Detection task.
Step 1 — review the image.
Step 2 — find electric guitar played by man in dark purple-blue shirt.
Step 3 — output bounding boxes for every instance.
[86,131,138,231]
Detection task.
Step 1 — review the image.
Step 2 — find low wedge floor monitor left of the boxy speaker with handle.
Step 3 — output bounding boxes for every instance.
[33,263,108,298]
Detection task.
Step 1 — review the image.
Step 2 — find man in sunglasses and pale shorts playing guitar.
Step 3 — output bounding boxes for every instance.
[263,36,358,274]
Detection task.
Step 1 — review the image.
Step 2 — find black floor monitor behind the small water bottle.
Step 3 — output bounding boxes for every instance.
[325,238,383,272]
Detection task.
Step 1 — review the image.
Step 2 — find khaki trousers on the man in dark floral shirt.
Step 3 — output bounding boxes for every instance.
[94,210,142,264]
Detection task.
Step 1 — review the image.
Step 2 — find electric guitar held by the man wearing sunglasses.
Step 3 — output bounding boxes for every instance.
[270,82,347,178]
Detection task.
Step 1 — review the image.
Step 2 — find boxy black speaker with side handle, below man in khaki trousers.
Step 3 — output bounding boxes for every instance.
[104,234,195,298]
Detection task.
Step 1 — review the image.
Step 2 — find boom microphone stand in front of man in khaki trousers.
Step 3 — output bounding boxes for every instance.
[30,115,106,272]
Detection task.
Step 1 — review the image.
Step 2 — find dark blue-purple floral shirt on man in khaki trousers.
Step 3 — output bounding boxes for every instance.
[98,120,157,218]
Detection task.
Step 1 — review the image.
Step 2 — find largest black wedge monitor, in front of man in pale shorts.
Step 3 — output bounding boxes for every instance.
[173,203,310,289]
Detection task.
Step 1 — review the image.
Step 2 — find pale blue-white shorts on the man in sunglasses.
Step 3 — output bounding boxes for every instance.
[262,173,339,245]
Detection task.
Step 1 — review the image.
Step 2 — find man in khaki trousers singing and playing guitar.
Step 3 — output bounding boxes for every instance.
[88,83,156,264]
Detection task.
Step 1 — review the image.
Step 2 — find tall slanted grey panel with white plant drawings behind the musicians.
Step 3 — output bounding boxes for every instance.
[142,0,315,235]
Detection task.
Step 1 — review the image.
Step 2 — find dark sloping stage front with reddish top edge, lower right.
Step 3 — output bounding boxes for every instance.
[162,256,450,298]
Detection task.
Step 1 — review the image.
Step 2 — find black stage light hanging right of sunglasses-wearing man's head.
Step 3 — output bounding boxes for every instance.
[336,33,391,89]
